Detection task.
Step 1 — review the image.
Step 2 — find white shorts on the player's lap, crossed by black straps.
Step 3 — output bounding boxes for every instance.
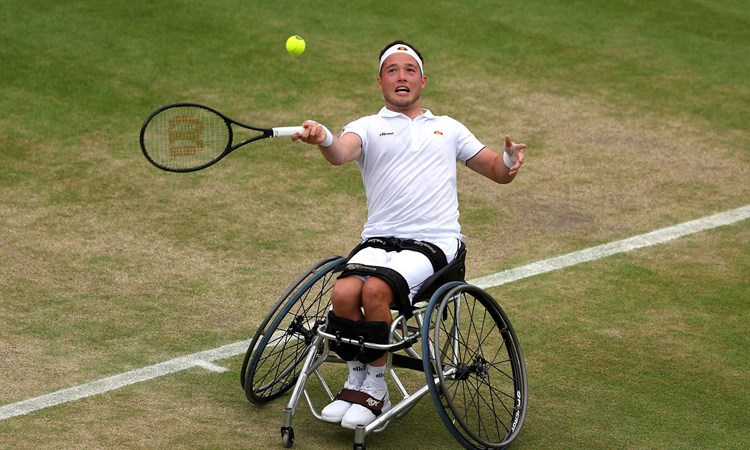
[349,238,460,302]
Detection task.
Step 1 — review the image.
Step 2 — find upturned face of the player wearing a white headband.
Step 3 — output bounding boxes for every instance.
[378,53,427,115]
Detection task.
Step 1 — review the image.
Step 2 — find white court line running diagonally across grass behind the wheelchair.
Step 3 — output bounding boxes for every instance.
[0,205,750,420]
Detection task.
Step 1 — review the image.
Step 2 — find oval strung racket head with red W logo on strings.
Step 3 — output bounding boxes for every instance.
[144,106,232,169]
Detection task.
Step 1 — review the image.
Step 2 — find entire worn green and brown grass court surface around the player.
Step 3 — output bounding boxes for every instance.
[0,0,750,449]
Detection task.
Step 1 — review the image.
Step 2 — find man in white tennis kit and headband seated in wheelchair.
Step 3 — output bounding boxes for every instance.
[292,41,526,429]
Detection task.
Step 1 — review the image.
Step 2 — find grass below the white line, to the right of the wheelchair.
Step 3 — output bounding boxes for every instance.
[506,225,750,448]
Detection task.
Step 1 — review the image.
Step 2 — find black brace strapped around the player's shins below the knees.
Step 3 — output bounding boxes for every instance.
[326,311,391,364]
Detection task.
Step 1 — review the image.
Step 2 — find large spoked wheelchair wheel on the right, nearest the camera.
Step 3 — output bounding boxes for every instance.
[422,282,528,449]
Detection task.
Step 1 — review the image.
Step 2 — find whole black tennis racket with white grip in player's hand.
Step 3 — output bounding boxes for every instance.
[141,103,304,172]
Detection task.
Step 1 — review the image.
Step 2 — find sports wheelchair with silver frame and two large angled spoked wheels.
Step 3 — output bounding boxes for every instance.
[240,246,528,450]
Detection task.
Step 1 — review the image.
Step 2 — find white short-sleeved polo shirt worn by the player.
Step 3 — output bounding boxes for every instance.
[342,108,484,241]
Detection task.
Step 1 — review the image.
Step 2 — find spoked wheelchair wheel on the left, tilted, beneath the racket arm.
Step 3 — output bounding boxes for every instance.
[241,256,345,403]
